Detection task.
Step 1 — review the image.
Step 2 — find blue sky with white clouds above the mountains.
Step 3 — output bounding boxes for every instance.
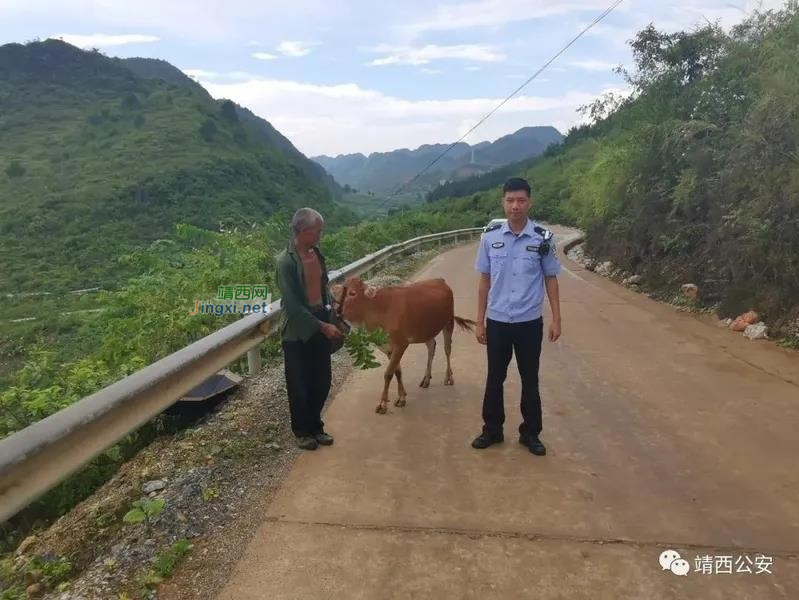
[0,0,784,156]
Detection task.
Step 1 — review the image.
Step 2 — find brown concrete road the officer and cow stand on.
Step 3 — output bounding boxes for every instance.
[220,230,799,600]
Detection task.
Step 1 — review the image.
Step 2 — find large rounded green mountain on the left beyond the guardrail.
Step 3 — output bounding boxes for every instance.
[0,40,351,293]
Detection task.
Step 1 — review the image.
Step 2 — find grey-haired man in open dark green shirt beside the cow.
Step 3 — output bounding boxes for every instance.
[277,208,341,450]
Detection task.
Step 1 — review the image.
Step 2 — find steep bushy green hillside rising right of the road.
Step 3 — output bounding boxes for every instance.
[418,3,799,347]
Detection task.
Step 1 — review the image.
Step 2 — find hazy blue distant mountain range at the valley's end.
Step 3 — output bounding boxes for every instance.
[311,126,563,194]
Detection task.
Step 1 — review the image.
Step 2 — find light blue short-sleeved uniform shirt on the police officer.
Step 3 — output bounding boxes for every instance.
[474,219,561,323]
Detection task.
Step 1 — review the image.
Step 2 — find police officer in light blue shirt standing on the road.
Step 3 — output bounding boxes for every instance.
[472,177,561,456]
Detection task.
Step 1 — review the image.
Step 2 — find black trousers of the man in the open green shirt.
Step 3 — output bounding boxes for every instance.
[282,309,331,437]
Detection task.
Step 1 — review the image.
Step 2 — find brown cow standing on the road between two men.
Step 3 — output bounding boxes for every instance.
[333,277,475,414]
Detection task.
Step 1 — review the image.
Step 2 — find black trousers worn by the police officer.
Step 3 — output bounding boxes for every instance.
[483,317,544,436]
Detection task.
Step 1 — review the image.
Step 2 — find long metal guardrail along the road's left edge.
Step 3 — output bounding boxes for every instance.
[0,227,482,523]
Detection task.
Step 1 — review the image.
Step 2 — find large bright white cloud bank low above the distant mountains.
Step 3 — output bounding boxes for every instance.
[192,72,624,156]
